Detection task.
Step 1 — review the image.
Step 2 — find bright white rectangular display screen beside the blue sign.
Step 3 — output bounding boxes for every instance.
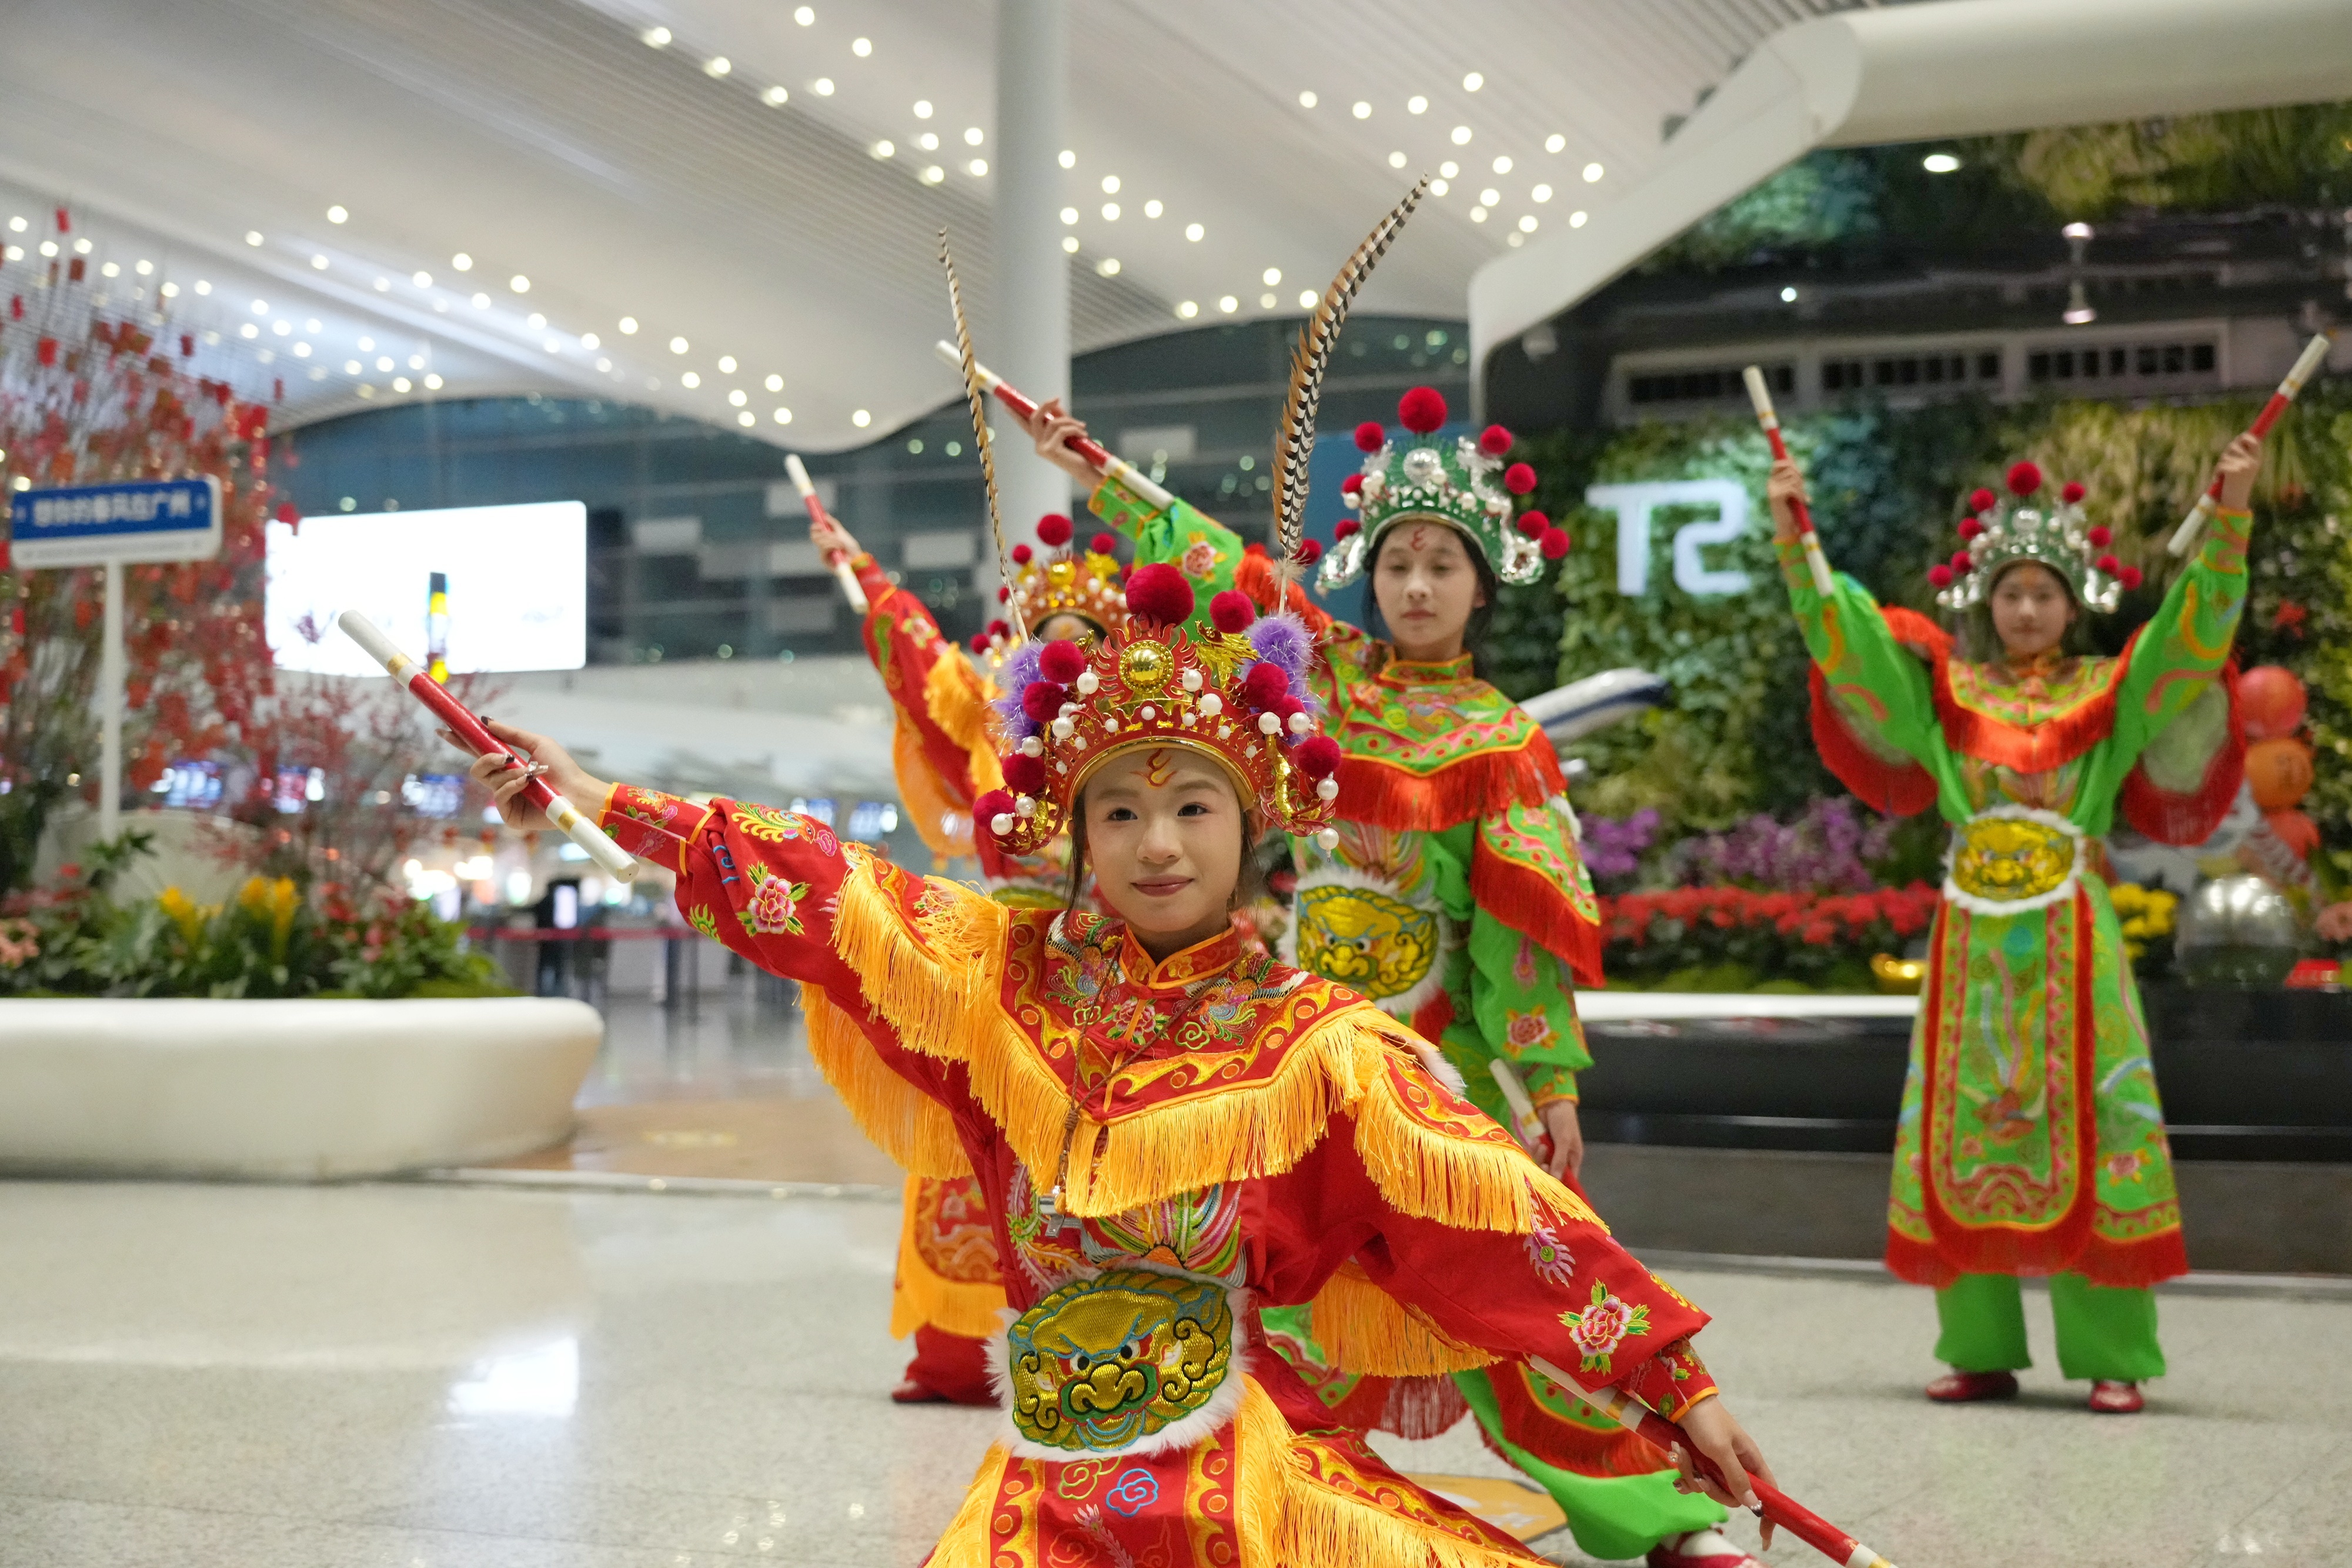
[263,501,588,675]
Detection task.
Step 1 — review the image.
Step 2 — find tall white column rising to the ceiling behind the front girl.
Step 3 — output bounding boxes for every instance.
[978,0,1073,557]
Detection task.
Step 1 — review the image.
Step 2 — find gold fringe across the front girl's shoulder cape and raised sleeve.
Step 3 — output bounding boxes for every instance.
[811,855,1599,1234]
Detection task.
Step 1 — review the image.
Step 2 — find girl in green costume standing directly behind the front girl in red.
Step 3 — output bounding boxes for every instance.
[1030,388,1762,1568]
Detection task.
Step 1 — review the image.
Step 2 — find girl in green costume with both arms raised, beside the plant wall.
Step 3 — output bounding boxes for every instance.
[1769,435,2260,1413]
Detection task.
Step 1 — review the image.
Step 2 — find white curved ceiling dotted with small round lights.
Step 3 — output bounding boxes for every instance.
[0,0,1853,452]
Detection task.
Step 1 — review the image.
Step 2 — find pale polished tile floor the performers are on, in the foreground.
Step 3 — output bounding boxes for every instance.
[0,1182,2352,1568]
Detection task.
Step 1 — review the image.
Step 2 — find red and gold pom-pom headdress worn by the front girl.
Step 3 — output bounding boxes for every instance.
[971,567,1338,855]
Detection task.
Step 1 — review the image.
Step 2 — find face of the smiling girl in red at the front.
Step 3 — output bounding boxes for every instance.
[1082,745,1249,959]
